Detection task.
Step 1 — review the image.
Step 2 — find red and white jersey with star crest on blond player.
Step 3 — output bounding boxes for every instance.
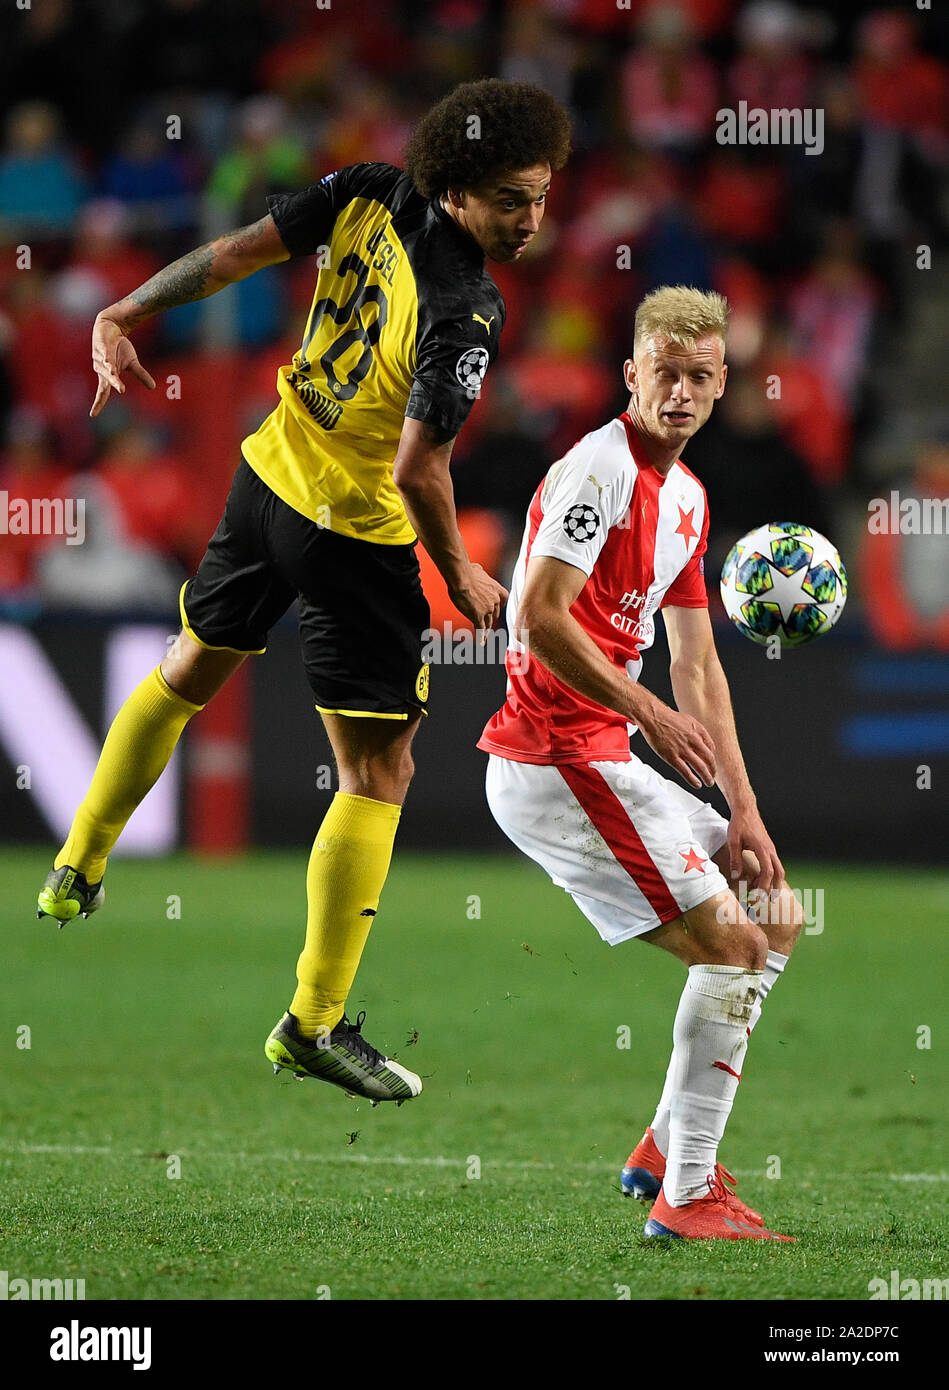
[478,413,709,763]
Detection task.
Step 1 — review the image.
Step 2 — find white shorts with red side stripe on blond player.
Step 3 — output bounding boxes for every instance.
[486,753,728,945]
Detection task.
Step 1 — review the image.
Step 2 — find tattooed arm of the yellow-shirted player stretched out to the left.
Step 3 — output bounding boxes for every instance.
[89,213,290,416]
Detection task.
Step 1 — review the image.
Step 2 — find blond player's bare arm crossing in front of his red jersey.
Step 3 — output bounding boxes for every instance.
[514,555,716,787]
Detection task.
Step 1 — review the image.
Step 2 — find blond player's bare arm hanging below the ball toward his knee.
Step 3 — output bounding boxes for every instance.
[663,605,784,890]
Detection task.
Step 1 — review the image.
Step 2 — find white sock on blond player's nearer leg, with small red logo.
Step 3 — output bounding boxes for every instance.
[663,965,763,1207]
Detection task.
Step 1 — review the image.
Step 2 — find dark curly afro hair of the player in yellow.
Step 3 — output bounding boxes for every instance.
[404,78,570,197]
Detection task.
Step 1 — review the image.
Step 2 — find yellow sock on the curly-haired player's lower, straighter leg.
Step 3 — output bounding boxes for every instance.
[290,791,402,1038]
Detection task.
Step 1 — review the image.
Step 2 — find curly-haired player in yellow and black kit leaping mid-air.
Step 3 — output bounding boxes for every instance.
[39,78,570,1101]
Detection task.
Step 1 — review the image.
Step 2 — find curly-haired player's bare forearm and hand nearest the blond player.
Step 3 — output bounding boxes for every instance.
[393,416,507,631]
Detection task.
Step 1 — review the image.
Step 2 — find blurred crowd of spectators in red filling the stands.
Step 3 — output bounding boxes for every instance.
[0,0,949,635]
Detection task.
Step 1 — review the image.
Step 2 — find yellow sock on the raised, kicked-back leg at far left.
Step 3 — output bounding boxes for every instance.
[53,666,204,883]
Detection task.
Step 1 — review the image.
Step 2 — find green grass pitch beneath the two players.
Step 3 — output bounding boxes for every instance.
[0,849,949,1300]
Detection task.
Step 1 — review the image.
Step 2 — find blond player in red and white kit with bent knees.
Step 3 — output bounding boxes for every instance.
[478,285,802,1240]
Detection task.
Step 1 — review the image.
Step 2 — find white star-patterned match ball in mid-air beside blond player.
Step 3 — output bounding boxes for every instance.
[721,521,846,646]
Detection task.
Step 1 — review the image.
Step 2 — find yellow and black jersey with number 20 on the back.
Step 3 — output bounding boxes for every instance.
[242,164,504,545]
